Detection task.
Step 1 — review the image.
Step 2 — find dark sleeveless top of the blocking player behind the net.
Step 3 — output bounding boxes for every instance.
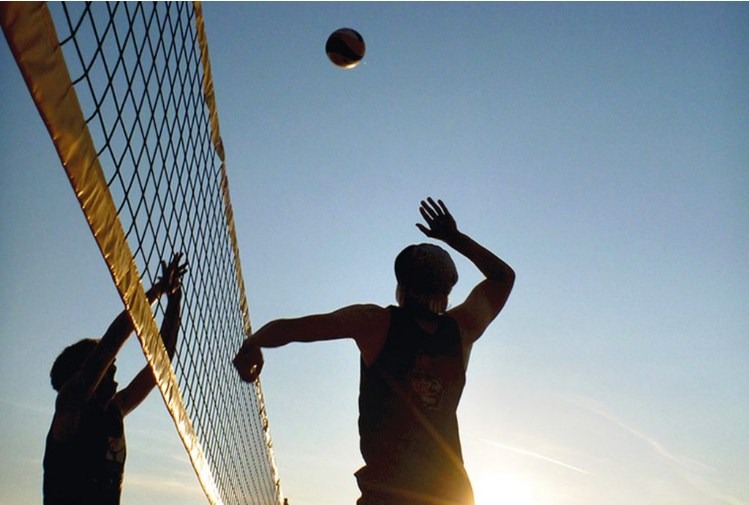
[43,404,126,505]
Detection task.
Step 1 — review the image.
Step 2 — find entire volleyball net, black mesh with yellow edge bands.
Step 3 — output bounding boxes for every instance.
[0,2,283,505]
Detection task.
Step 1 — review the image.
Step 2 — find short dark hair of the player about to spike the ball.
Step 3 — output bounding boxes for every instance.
[395,244,458,295]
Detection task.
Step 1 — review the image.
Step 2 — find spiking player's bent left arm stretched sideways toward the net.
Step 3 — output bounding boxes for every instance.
[233,304,390,382]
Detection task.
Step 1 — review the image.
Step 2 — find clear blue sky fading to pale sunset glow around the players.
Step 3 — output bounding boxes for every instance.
[0,3,749,505]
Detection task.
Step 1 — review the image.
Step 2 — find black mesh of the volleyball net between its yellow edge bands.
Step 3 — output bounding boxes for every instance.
[50,2,280,505]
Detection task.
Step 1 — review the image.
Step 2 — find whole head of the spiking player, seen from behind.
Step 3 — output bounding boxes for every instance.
[395,244,458,314]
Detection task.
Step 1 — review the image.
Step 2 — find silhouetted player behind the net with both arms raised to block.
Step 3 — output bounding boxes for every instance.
[43,254,187,505]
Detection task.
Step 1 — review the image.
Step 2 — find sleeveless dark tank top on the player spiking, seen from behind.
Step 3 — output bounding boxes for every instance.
[356,307,473,505]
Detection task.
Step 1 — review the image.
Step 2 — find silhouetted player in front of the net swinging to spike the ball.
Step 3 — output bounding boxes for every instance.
[234,198,515,505]
